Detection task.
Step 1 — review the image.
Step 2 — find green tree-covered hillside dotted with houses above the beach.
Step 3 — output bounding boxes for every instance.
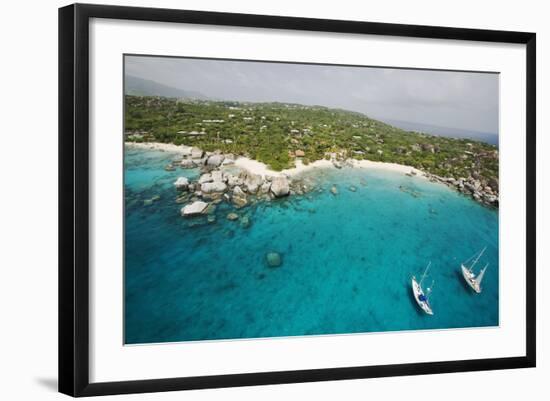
[125,96,498,190]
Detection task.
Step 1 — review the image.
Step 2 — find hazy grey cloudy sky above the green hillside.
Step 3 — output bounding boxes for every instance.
[125,56,499,134]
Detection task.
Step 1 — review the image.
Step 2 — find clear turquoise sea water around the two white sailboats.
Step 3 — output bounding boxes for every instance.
[124,148,499,344]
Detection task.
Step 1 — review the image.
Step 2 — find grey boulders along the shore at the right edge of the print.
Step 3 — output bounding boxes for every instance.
[425,172,499,207]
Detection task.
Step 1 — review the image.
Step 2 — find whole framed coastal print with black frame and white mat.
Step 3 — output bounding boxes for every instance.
[59,4,536,396]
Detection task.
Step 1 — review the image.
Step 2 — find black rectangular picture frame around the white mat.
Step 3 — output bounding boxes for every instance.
[59,4,536,396]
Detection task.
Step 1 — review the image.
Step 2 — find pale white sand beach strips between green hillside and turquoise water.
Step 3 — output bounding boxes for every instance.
[124,142,426,178]
